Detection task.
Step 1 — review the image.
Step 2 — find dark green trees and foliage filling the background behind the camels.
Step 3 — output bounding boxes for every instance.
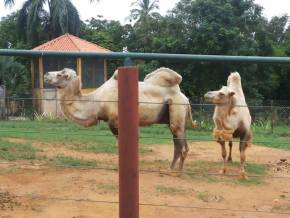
[0,0,290,104]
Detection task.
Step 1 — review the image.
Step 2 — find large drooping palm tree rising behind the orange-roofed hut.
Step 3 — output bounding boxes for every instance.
[4,0,98,45]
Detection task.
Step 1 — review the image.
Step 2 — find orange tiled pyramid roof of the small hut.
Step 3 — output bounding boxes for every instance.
[32,33,111,52]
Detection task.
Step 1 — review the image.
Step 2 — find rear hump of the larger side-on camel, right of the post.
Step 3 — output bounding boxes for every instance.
[144,67,182,87]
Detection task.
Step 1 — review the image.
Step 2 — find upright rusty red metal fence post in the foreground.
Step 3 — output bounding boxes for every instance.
[118,67,139,218]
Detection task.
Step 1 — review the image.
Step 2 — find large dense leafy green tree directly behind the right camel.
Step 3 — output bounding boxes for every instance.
[147,0,277,99]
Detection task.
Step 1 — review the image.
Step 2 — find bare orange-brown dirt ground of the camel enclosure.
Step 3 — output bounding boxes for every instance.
[0,139,290,218]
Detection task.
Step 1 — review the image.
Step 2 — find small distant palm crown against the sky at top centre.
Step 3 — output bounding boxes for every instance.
[129,0,160,22]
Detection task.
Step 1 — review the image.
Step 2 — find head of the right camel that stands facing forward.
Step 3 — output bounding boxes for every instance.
[204,86,235,104]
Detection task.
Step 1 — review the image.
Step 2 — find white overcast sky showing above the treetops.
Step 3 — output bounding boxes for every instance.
[0,0,290,23]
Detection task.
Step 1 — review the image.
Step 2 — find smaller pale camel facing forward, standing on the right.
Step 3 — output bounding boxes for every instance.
[204,72,252,179]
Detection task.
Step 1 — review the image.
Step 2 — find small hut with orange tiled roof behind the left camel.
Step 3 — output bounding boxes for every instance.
[31,34,111,115]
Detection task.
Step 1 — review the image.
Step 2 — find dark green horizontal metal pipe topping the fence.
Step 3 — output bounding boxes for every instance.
[0,49,290,64]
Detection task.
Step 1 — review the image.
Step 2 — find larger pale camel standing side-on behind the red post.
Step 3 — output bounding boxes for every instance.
[44,68,196,170]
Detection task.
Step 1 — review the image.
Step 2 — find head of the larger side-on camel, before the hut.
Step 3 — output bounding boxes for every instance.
[44,68,77,89]
